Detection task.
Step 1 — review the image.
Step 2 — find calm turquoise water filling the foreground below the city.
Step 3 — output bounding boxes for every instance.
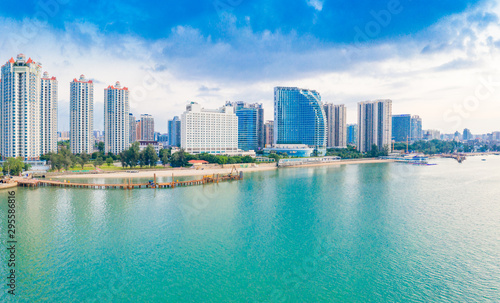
[0,156,500,302]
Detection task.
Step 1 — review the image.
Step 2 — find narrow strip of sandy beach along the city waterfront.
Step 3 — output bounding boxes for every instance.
[49,159,394,179]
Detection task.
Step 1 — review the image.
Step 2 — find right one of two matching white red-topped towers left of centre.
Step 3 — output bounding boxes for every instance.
[104,82,130,155]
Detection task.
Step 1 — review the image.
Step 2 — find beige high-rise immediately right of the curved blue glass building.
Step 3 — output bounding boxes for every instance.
[323,103,347,148]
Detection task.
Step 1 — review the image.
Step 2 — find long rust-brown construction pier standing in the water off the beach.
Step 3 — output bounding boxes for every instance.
[17,172,243,189]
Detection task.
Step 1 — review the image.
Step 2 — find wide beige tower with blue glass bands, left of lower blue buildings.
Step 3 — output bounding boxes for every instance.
[358,100,392,152]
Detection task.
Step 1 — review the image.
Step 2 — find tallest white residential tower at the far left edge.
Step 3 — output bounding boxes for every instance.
[0,54,46,160]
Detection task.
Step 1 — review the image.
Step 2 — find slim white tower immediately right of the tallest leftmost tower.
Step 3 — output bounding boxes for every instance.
[40,72,58,155]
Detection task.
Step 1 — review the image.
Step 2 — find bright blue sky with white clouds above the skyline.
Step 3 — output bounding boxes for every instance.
[0,0,500,134]
